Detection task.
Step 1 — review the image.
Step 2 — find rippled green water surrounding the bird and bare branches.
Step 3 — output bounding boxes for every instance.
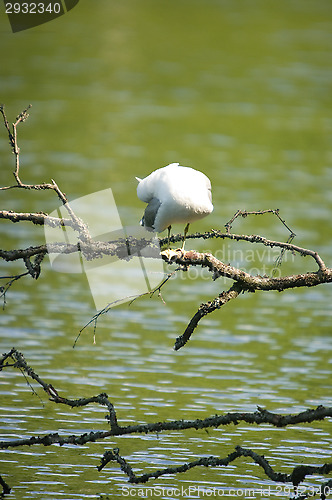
[0,0,332,500]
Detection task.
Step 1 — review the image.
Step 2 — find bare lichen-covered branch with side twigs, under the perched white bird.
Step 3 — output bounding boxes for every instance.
[0,106,332,350]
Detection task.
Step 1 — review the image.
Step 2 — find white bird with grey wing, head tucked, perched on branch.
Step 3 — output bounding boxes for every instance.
[136,163,213,250]
